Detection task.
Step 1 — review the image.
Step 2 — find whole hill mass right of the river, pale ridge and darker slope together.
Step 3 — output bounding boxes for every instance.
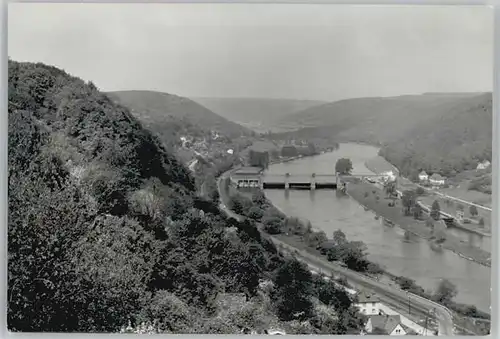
[272,93,492,178]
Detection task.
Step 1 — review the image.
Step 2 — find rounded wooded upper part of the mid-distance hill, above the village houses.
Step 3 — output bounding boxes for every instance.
[107,91,252,137]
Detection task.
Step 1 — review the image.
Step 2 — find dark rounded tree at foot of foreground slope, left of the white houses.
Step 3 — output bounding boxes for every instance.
[273,259,313,321]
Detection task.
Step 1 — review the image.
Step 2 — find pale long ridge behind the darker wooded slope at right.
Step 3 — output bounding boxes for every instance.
[280,93,484,143]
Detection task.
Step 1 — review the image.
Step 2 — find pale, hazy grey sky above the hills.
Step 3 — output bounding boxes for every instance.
[8,3,493,101]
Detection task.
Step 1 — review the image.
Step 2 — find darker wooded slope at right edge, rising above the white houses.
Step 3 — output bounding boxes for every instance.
[380,94,493,177]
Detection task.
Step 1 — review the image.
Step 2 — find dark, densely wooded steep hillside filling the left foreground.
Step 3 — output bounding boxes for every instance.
[7,61,363,334]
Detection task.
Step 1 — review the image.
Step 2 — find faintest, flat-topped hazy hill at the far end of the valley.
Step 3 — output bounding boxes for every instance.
[192,98,325,131]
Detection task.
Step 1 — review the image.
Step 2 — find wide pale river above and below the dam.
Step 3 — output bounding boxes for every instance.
[265,144,491,312]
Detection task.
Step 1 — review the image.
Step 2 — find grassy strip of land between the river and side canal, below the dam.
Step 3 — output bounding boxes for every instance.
[347,182,491,267]
